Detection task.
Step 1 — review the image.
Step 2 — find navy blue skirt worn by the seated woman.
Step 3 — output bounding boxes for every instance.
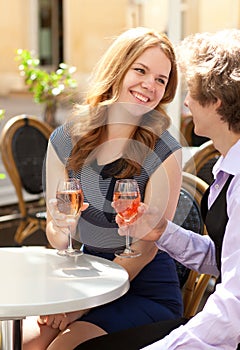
[79,247,183,333]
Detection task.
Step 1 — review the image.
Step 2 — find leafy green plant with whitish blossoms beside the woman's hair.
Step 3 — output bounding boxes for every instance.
[16,49,77,127]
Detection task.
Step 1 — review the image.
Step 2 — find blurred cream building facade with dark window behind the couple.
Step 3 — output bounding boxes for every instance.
[0,0,240,95]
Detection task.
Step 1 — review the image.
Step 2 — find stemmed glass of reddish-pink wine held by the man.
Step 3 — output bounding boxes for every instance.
[113,179,141,258]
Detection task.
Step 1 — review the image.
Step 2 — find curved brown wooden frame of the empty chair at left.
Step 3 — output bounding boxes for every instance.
[0,114,53,244]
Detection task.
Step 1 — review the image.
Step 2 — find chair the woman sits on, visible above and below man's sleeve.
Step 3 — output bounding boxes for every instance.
[173,172,211,317]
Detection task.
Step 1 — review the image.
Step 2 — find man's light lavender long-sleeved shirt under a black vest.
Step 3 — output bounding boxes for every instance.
[144,140,240,350]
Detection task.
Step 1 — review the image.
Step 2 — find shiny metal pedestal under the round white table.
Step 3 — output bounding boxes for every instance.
[0,320,22,350]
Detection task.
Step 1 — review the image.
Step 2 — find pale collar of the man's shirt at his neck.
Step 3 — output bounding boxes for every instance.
[212,140,240,178]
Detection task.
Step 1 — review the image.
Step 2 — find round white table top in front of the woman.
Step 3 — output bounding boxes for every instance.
[0,247,129,319]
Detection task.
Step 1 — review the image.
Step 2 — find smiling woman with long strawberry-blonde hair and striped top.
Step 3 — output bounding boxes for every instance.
[24,28,182,350]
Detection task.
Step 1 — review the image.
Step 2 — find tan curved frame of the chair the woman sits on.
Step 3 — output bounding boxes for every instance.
[182,172,211,318]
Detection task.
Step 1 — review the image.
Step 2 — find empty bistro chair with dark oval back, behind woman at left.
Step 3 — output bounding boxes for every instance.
[0,115,52,244]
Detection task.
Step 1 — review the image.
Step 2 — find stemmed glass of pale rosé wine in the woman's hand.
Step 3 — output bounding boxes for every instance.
[56,178,83,256]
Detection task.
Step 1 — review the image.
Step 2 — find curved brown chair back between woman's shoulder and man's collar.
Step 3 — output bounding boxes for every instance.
[183,140,220,185]
